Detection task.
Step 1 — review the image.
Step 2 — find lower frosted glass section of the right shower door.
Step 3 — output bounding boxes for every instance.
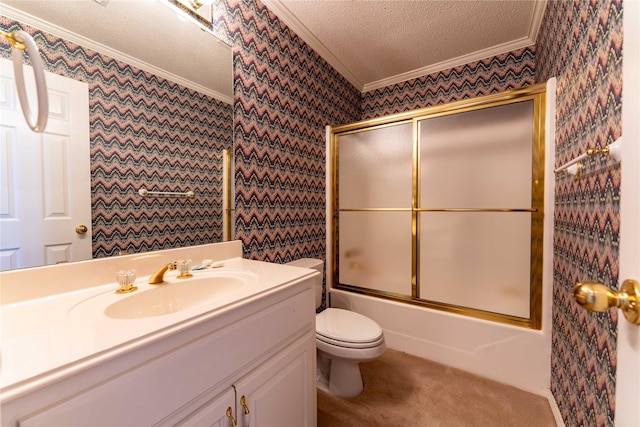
[418,212,531,318]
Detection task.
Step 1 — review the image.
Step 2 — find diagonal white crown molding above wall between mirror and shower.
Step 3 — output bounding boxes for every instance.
[262,0,364,92]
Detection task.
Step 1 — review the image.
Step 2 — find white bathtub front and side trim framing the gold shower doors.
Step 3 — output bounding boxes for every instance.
[326,78,556,396]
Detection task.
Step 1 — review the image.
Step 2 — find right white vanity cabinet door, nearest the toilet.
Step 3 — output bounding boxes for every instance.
[234,334,316,427]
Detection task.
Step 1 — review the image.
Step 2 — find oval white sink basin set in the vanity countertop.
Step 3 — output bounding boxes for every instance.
[104,276,248,319]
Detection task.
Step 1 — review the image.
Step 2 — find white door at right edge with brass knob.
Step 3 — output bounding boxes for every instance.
[615,1,640,427]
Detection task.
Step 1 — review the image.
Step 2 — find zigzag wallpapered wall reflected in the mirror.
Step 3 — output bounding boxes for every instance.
[0,18,233,258]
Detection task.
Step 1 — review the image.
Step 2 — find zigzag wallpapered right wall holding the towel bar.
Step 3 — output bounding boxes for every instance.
[536,0,622,426]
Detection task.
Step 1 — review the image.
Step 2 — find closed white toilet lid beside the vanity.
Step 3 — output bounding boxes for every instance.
[316,308,382,343]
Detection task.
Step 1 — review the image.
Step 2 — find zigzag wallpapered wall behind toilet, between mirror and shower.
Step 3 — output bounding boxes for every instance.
[224,0,360,262]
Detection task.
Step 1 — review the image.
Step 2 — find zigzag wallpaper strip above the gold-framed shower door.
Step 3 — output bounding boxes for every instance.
[362,47,536,119]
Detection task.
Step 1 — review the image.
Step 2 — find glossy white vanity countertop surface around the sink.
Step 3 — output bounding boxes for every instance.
[0,258,315,401]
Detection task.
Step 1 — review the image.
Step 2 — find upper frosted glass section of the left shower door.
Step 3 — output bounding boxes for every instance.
[338,123,413,208]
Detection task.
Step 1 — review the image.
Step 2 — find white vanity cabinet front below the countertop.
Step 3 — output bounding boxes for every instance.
[2,277,316,427]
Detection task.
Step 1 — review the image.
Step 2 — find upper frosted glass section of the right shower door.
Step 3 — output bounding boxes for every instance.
[419,101,533,208]
